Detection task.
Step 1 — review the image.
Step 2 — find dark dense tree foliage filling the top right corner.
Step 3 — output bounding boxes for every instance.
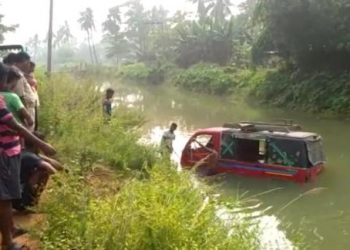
[253,0,350,71]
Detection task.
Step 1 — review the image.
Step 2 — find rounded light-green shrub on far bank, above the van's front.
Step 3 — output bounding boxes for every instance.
[174,64,236,95]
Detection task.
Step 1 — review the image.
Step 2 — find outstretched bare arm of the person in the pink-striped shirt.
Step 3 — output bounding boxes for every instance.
[2,118,56,155]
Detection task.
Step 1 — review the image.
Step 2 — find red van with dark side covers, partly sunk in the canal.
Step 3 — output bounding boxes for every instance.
[181,122,325,182]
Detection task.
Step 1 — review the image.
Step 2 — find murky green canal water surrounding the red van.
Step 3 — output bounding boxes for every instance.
[106,83,350,250]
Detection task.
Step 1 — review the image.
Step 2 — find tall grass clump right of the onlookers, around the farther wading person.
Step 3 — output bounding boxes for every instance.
[39,75,155,169]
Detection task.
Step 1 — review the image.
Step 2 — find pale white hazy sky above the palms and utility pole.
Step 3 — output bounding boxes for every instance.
[0,0,191,44]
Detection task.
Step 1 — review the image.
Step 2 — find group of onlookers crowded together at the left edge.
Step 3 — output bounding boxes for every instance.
[0,52,62,250]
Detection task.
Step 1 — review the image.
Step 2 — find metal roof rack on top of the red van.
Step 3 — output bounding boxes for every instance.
[223,120,302,133]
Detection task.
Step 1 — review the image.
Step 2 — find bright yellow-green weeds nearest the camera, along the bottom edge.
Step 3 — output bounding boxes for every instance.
[41,164,258,250]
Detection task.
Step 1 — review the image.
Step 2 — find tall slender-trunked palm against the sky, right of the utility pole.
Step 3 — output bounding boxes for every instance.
[78,8,98,63]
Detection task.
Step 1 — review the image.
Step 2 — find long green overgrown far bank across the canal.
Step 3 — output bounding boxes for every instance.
[116,64,350,115]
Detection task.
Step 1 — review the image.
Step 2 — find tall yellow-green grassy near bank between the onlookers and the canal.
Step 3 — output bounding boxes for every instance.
[37,75,258,250]
